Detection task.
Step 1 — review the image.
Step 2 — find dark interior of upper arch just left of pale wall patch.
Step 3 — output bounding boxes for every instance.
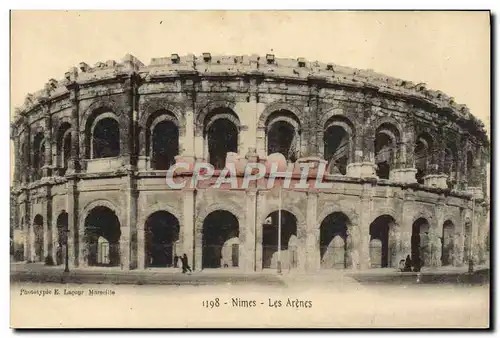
[206,118,238,169]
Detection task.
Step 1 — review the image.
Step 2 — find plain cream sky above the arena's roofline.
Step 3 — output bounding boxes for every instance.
[11,11,490,133]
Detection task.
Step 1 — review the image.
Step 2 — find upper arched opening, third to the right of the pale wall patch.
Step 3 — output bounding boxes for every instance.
[374,123,399,179]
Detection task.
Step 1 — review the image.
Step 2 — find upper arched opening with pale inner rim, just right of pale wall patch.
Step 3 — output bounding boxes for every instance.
[266,110,300,162]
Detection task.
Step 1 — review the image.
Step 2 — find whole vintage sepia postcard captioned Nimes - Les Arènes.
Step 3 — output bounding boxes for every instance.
[10,11,491,329]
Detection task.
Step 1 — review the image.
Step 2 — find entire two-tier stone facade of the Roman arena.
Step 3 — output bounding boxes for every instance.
[11,53,490,272]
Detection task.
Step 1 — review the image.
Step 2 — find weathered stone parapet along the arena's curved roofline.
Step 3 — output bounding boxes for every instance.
[11,53,486,139]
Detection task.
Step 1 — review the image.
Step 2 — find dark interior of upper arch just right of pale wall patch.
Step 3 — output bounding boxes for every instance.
[267,121,297,162]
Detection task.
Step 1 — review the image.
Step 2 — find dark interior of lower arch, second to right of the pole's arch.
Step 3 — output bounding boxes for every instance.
[370,215,394,268]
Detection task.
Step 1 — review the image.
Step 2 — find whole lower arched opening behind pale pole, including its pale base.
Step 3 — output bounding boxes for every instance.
[262,210,298,270]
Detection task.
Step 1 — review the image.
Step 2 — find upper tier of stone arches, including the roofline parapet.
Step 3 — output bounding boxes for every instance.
[11,53,489,199]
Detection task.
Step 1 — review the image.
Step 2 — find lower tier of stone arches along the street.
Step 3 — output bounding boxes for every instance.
[14,175,489,272]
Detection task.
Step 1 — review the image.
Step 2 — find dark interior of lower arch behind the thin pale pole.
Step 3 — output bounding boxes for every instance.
[262,210,297,268]
